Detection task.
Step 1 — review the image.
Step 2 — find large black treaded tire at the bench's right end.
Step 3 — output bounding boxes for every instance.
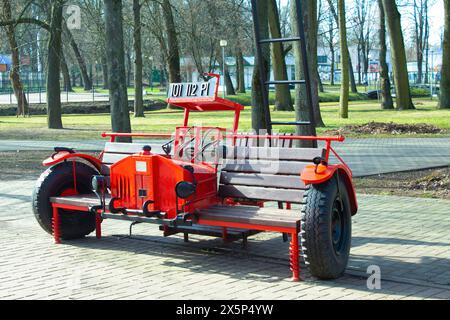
[301,175,352,280]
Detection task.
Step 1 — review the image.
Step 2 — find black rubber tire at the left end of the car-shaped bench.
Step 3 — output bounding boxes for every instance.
[32,161,98,240]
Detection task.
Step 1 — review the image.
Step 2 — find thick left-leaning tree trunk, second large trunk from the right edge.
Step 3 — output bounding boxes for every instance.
[383,0,415,110]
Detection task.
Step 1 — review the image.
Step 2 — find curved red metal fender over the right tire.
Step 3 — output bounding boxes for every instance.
[300,164,358,215]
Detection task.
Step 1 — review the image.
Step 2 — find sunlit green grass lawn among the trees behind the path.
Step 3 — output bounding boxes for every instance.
[0,99,450,140]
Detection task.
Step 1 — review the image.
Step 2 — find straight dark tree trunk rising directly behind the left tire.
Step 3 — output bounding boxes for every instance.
[47,0,64,129]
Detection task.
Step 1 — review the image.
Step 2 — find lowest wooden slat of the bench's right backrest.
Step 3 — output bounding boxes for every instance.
[219,185,303,203]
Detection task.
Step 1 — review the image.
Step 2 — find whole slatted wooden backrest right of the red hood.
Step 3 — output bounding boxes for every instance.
[219,145,324,203]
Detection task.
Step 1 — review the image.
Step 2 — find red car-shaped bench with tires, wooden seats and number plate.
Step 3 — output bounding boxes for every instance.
[33,74,357,280]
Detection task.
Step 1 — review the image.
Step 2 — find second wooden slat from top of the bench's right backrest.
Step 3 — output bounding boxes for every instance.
[222,160,311,176]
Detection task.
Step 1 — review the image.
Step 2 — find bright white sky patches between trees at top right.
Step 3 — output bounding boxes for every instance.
[279,0,444,47]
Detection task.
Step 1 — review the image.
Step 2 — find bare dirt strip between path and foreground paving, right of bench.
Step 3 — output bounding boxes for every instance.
[354,167,450,200]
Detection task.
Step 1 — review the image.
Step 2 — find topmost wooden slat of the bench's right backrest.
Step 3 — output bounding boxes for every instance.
[224,146,323,161]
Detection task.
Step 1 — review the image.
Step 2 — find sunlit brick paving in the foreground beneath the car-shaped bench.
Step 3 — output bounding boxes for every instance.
[0,181,450,299]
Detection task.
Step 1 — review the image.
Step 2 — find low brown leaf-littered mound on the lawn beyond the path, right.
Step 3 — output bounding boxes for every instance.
[326,122,444,135]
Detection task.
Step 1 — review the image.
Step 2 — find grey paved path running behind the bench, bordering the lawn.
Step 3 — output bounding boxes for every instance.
[0,138,450,176]
